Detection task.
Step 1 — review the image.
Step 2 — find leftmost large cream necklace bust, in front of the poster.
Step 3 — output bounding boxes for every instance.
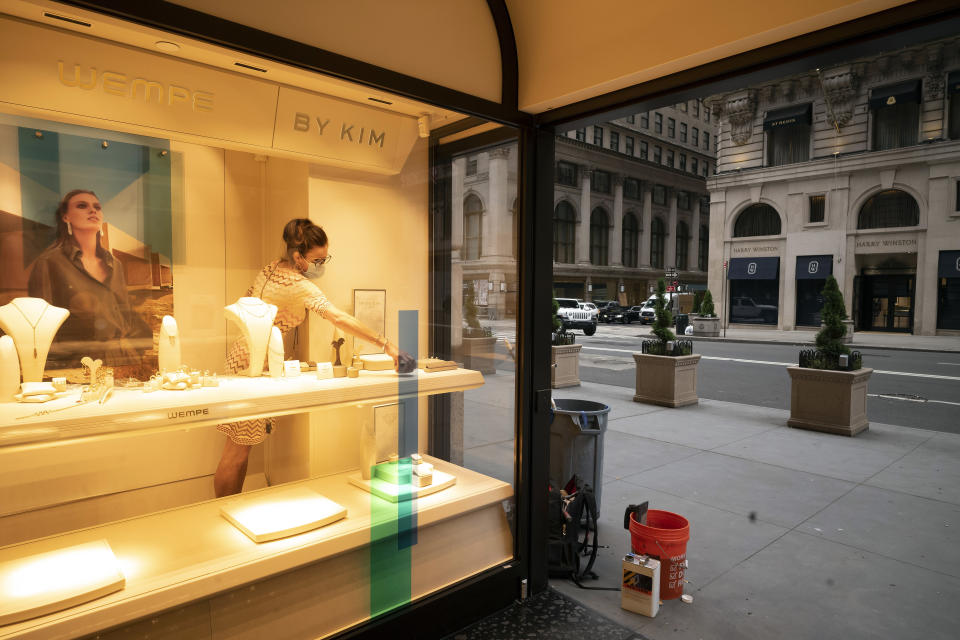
[0,298,70,382]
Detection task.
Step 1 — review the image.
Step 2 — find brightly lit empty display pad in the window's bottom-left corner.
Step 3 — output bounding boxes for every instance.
[0,540,125,625]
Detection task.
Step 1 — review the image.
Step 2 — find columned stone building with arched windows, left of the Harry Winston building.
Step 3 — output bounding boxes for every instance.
[452,100,716,319]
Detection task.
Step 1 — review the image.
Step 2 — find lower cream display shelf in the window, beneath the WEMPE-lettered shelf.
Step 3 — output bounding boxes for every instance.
[0,456,513,639]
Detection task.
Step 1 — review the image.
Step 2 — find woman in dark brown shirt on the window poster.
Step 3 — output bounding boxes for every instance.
[27,189,153,368]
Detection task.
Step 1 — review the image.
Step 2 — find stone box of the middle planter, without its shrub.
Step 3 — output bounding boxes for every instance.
[633,353,700,407]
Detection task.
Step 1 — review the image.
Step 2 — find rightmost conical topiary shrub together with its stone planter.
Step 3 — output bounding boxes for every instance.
[787,276,873,436]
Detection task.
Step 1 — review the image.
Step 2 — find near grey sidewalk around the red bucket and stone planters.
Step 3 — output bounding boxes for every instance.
[464,370,960,640]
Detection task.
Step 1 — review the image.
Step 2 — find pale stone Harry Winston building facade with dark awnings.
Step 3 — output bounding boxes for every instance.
[705,38,960,335]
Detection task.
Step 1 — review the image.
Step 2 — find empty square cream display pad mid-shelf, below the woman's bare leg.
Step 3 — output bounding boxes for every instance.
[220,487,347,542]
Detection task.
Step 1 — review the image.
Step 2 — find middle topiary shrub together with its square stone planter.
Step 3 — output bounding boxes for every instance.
[633,279,700,407]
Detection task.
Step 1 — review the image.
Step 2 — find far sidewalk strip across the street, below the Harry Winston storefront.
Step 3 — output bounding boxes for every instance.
[484,319,960,351]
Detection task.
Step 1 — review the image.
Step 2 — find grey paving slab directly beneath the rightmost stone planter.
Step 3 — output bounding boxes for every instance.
[713,425,933,482]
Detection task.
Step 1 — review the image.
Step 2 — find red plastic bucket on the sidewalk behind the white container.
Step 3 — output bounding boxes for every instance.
[630,509,690,600]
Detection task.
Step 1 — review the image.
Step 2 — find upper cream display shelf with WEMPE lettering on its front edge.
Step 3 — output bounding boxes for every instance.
[0,369,483,446]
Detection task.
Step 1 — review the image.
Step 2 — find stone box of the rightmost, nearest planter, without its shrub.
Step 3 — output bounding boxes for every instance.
[787,367,873,436]
